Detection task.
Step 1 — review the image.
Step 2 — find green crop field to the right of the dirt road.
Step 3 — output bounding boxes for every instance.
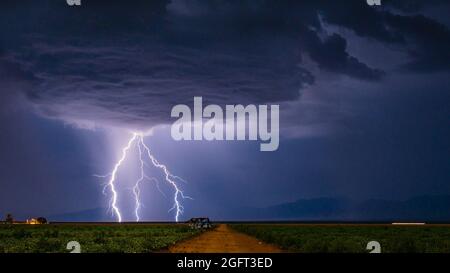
[232,224,450,253]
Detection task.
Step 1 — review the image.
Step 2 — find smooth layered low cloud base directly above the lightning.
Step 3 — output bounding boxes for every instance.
[7,39,312,129]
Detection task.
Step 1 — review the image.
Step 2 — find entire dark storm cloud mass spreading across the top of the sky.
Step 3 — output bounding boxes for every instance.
[0,0,449,128]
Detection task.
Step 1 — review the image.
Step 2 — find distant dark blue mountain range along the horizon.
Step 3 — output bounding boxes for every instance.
[48,195,450,222]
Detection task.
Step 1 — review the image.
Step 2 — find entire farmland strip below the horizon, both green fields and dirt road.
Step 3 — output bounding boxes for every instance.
[0,223,450,253]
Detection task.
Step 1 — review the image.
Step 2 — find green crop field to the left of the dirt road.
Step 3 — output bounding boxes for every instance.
[0,224,198,253]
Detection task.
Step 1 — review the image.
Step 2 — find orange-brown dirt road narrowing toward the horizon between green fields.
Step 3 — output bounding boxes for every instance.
[169,224,281,253]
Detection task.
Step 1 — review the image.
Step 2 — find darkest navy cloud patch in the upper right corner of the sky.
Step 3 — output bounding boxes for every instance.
[324,0,450,73]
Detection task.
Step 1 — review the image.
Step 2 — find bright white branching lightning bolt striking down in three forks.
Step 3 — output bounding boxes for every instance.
[96,133,192,222]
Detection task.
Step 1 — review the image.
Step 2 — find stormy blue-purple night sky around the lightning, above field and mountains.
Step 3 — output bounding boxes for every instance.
[0,0,450,220]
